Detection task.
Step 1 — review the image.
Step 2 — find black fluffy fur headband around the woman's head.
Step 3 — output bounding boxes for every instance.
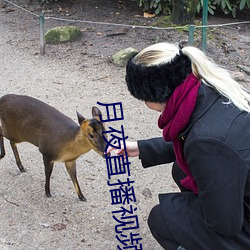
[126,51,192,103]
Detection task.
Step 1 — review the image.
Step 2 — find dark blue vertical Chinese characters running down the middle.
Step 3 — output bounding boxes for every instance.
[97,102,142,250]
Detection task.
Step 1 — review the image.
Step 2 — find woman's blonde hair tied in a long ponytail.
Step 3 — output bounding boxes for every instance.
[134,43,250,113]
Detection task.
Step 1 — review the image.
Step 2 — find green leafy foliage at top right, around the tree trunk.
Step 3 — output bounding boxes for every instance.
[136,0,250,17]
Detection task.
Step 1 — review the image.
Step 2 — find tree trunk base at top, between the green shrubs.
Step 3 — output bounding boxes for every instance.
[171,0,198,25]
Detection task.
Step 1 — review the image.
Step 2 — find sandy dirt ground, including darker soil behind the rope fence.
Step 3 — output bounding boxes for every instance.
[0,0,250,250]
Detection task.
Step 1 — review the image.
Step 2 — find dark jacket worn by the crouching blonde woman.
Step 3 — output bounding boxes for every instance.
[138,85,250,250]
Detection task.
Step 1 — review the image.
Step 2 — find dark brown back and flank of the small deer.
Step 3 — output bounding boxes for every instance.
[0,94,79,147]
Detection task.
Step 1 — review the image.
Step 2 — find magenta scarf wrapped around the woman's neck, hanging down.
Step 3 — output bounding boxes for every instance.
[158,73,200,194]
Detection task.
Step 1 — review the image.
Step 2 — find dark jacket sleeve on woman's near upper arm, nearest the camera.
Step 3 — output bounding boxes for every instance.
[184,137,248,237]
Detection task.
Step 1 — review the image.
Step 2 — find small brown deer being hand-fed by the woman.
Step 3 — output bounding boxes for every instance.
[0,94,109,201]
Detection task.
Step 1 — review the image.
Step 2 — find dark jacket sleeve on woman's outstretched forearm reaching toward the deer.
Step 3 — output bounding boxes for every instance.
[138,137,175,168]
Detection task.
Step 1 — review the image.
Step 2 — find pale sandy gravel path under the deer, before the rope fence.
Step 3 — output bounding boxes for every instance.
[0,3,175,250]
